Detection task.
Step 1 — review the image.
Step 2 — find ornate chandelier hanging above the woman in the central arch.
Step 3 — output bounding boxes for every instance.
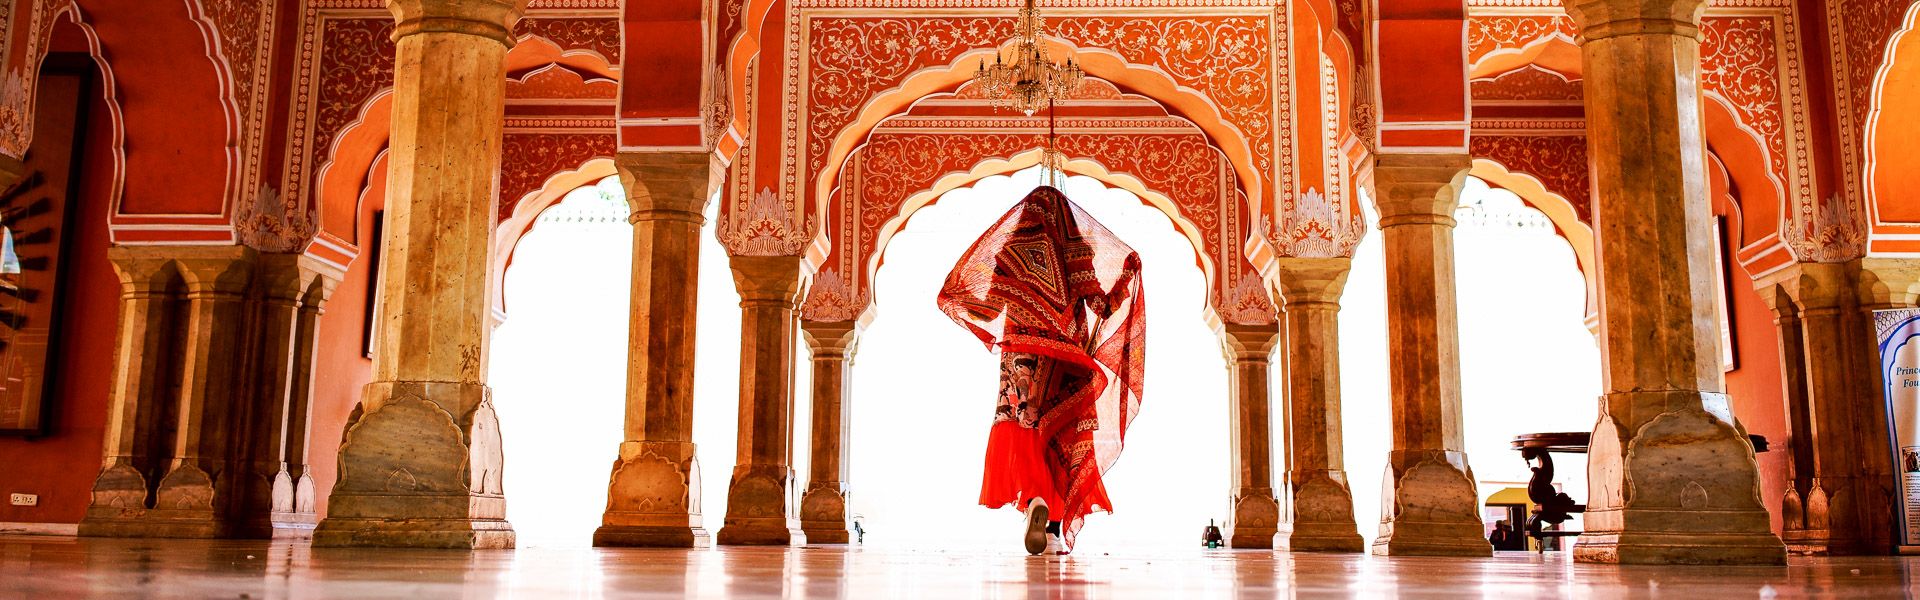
[973,0,1087,117]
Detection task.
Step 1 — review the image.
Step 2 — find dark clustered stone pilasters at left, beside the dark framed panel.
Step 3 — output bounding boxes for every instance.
[79,246,255,538]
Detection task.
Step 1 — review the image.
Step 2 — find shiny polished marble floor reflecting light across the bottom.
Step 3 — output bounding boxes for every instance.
[0,537,1920,600]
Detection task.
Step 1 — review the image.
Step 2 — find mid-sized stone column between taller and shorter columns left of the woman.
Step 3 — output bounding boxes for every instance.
[718,256,806,546]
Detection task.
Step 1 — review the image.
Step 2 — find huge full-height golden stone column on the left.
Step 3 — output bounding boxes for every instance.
[313,0,526,548]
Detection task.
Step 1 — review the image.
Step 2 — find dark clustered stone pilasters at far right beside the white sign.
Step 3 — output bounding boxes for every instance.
[1761,262,1897,554]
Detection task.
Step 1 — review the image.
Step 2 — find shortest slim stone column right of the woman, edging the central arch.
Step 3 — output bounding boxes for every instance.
[1221,323,1283,548]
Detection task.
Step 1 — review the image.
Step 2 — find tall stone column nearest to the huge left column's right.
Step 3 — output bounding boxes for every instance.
[593,152,718,548]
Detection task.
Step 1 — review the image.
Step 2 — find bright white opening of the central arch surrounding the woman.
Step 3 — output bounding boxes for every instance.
[849,167,1231,552]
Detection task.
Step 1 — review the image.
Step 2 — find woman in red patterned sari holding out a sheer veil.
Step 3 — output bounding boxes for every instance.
[939,187,1146,554]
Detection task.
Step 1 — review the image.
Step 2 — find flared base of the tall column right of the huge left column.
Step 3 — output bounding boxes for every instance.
[593,440,712,548]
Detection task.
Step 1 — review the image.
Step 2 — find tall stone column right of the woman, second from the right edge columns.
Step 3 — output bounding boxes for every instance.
[1373,154,1494,556]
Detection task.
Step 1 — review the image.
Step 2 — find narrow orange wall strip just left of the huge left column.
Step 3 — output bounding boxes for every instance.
[307,160,386,517]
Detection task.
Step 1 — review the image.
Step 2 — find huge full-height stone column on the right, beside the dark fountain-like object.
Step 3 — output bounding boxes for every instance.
[1565,0,1786,563]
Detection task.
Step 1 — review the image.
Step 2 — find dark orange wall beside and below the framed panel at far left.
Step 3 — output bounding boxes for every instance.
[0,59,119,523]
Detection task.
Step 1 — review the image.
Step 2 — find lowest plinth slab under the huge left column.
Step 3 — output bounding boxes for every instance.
[313,517,515,550]
